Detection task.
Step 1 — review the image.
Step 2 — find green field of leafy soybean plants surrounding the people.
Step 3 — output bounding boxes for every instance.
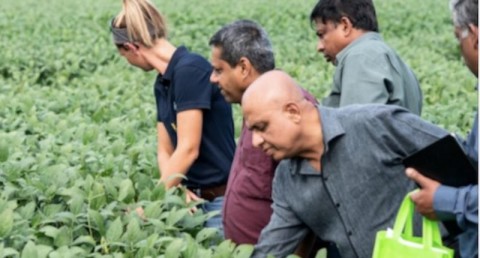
[0,0,477,258]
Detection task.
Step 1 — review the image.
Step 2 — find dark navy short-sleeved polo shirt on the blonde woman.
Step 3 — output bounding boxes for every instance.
[154,46,235,188]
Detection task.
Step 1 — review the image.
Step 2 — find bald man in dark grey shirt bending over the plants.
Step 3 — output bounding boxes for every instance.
[242,71,447,257]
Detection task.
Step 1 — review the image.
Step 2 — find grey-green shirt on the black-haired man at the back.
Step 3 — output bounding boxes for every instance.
[322,32,422,115]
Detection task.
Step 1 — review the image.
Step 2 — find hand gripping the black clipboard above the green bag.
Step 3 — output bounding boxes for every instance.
[405,168,440,220]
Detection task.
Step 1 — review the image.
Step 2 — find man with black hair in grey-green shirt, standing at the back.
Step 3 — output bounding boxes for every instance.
[310,0,422,115]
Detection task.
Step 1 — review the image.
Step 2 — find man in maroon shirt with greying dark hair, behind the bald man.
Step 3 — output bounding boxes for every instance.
[209,20,316,249]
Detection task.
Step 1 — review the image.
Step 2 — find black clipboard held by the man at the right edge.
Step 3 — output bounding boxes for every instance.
[403,135,478,187]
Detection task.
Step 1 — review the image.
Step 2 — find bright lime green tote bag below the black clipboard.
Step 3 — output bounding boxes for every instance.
[373,191,453,258]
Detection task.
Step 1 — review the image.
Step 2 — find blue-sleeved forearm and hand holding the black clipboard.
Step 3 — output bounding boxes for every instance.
[406,168,478,230]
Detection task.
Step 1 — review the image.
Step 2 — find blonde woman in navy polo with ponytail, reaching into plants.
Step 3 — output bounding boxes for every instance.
[111,0,235,233]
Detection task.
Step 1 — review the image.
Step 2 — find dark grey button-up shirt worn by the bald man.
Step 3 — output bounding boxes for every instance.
[253,104,447,258]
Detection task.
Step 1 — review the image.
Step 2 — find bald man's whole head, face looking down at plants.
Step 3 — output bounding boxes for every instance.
[242,71,322,160]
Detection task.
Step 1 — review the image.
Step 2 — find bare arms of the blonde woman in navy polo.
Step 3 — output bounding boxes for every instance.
[158,109,203,188]
